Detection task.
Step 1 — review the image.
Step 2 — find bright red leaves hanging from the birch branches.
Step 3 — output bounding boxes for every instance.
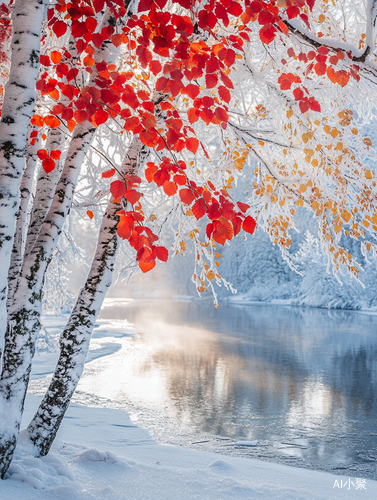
[32,0,364,271]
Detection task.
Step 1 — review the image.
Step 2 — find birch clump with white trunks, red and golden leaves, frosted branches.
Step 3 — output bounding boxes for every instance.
[0,0,377,477]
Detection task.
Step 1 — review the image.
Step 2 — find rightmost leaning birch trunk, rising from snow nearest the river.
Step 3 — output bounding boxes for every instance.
[27,137,149,456]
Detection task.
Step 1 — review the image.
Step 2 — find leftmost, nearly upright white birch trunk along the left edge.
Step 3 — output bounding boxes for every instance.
[0,0,48,368]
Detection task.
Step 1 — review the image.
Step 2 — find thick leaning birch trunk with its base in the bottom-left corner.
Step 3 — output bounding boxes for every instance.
[0,10,118,477]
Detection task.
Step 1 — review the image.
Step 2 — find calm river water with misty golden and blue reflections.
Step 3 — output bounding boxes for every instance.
[84,301,377,477]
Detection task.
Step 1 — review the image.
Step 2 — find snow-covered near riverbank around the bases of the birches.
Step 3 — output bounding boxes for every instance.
[0,310,377,500]
